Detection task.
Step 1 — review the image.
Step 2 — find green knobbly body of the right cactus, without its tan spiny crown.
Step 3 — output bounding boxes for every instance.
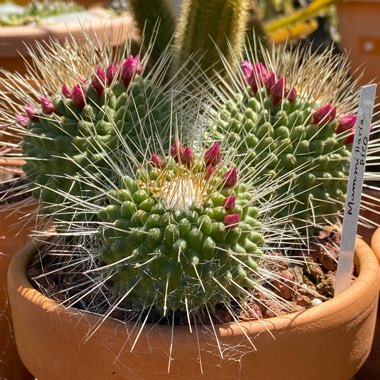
[210,62,350,226]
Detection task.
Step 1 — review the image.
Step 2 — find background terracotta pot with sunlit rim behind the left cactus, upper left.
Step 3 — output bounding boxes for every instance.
[0,9,136,73]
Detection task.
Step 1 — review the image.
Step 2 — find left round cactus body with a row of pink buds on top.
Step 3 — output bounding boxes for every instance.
[23,56,171,218]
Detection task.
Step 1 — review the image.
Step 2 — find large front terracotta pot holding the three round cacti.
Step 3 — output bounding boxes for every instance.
[8,240,380,380]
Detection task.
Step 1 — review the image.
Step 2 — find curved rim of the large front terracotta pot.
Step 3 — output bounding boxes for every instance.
[8,235,380,337]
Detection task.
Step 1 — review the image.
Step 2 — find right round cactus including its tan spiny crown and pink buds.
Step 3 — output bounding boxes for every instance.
[209,46,356,226]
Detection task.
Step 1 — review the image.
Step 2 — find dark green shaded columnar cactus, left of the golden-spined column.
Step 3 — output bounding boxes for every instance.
[128,0,176,62]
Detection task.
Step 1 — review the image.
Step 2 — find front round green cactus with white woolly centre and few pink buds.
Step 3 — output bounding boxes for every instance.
[99,145,264,314]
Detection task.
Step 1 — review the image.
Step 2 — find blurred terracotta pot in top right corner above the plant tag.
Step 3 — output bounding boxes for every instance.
[337,0,380,100]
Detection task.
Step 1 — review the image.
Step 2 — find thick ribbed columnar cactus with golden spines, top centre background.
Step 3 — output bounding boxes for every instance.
[175,0,250,79]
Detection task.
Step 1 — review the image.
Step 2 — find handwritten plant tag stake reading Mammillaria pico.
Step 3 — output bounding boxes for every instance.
[334,84,376,296]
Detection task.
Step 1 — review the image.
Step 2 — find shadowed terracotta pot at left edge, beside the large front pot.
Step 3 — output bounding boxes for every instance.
[0,201,36,380]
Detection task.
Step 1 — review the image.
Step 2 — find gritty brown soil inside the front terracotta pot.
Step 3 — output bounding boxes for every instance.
[28,227,354,325]
